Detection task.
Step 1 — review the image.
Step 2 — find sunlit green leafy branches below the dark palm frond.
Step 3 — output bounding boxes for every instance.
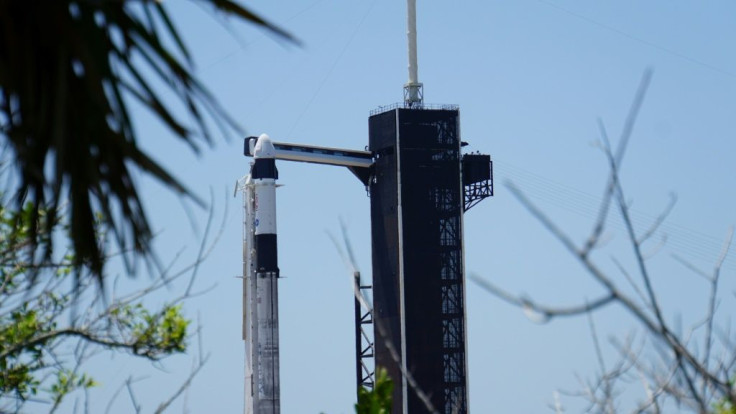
[0,201,189,413]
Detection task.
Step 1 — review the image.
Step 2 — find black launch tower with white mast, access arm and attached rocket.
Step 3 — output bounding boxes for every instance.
[242,0,493,414]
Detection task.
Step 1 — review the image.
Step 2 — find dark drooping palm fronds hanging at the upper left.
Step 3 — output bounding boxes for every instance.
[0,0,293,281]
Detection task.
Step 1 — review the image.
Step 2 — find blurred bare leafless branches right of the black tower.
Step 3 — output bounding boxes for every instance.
[486,70,736,414]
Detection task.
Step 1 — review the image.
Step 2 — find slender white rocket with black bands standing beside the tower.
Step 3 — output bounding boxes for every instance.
[246,134,281,414]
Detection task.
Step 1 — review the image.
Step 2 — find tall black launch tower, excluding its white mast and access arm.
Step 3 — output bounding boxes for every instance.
[368,103,493,414]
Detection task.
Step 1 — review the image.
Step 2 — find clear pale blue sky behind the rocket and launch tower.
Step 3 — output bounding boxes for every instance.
[44,0,736,414]
